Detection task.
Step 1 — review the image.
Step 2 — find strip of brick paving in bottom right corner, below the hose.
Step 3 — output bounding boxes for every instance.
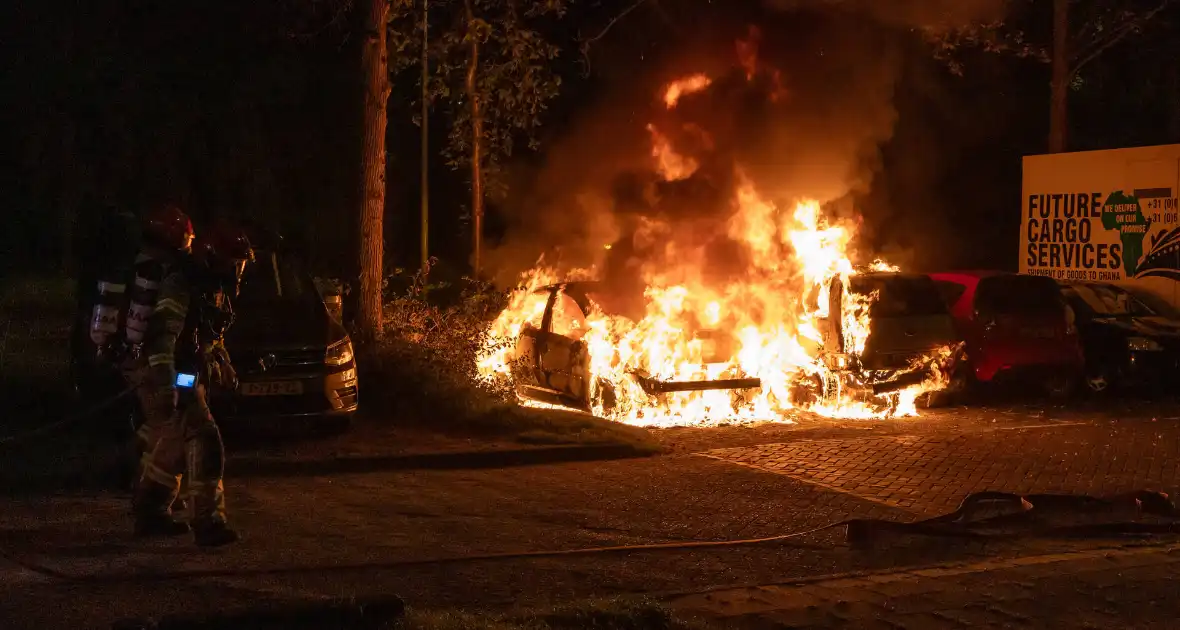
[670,545,1180,630]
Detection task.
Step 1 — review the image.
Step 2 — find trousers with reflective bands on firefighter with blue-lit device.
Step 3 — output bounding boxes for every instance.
[133,385,225,526]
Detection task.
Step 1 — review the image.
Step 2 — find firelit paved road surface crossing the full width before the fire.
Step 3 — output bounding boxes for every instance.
[0,420,1180,629]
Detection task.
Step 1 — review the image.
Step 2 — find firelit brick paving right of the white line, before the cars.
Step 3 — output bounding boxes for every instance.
[703,421,1180,516]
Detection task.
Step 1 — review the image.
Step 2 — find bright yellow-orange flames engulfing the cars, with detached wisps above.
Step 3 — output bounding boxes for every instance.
[478,65,949,426]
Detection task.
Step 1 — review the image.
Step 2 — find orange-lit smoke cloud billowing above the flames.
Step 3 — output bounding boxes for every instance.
[487,0,1002,284]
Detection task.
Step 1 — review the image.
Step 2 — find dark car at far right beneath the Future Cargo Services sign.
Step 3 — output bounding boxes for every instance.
[1062,282,1180,393]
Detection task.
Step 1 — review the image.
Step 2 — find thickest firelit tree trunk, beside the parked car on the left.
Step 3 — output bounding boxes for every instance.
[355,0,389,340]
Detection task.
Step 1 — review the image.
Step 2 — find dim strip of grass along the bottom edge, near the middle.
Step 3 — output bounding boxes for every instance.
[398,599,707,630]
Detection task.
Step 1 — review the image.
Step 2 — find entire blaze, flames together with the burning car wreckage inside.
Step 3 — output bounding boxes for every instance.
[479,29,959,426]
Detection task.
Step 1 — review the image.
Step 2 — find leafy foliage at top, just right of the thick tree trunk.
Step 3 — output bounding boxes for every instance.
[389,0,568,193]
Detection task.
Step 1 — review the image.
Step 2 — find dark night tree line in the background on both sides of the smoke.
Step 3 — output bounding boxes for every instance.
[0,0,1180,339]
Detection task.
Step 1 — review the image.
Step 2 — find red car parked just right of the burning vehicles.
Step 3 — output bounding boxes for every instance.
[930,271,1084,398]
